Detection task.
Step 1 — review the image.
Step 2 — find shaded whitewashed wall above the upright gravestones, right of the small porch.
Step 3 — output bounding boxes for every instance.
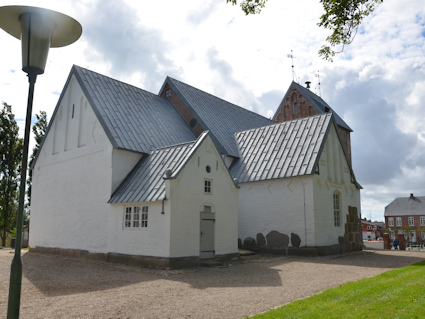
[239,175,315,246]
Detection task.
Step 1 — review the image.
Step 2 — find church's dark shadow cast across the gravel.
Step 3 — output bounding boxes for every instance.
[23,251,425,296]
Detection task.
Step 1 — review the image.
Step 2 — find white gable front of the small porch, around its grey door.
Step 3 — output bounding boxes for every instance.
[167,136,239,257]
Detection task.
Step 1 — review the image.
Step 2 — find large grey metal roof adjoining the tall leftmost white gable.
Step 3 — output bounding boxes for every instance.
[71,65,196,153]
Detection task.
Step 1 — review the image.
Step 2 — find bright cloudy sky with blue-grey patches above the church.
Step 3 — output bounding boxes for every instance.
[0,0,425,220]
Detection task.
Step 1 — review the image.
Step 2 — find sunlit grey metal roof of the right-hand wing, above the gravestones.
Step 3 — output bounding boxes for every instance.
[230,113,334,183]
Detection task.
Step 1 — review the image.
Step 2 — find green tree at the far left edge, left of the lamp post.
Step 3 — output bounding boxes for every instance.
[0,102,24,246]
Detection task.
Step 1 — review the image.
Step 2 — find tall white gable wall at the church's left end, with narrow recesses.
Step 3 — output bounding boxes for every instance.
[29,77,112,252]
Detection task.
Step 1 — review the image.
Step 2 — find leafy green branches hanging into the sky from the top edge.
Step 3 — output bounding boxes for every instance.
[227,0,383,62]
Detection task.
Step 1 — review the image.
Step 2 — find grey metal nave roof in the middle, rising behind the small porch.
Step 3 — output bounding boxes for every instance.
[160,77,276,157]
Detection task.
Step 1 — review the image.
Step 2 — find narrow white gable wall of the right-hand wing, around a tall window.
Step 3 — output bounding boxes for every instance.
[314,124,360,246]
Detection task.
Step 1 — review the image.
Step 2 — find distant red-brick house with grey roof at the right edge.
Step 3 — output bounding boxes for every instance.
[384,194,425,243]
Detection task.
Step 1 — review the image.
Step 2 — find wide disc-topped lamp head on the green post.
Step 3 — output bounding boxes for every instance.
[0,6,82,75]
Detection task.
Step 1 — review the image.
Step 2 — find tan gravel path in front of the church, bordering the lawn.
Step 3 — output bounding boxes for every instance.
[0,249,425,319]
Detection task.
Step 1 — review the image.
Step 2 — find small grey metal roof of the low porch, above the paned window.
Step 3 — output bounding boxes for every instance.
[108,132,208,203]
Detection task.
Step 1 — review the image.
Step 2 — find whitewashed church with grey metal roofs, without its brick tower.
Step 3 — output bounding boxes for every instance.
[30,66,361,268]
